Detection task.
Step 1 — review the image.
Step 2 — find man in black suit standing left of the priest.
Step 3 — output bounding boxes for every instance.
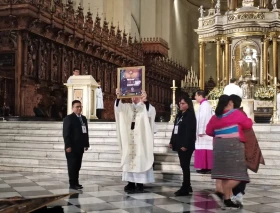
[63,100,89,190]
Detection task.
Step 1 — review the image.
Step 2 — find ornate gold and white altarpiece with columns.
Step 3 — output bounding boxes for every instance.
[195,0,280,122]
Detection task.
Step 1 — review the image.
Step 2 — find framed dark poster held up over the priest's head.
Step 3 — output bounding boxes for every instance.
[117,66,145,98]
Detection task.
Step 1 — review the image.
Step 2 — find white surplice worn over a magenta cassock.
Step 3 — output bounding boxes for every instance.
[195,100,214,150]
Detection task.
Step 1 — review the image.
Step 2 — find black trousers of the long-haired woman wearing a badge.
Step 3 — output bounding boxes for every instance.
[178,150,194,190]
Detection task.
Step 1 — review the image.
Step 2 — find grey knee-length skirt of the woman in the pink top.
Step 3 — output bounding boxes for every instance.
[211,138,250,182]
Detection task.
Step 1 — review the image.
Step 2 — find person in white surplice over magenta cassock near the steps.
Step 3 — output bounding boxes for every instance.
[194,90,214,174]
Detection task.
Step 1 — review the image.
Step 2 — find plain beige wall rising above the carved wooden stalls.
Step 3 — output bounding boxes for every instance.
[72,0,212,80]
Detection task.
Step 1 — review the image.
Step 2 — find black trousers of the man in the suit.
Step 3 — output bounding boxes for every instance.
[65,150,84,186]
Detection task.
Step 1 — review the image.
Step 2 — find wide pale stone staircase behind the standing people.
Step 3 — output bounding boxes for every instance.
[0,122,280,185]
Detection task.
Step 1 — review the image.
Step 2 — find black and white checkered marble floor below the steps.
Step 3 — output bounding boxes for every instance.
[0,171,280,213]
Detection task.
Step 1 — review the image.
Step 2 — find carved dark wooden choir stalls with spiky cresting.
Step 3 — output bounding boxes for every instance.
[0,0,187,119]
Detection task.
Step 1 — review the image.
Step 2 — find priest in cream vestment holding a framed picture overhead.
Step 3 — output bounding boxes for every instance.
[115,89,155,192]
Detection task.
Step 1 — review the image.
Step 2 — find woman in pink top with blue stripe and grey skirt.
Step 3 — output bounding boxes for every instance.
[206,95,253,209]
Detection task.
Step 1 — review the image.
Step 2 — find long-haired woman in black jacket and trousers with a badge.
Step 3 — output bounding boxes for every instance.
[169,97,196,196]
